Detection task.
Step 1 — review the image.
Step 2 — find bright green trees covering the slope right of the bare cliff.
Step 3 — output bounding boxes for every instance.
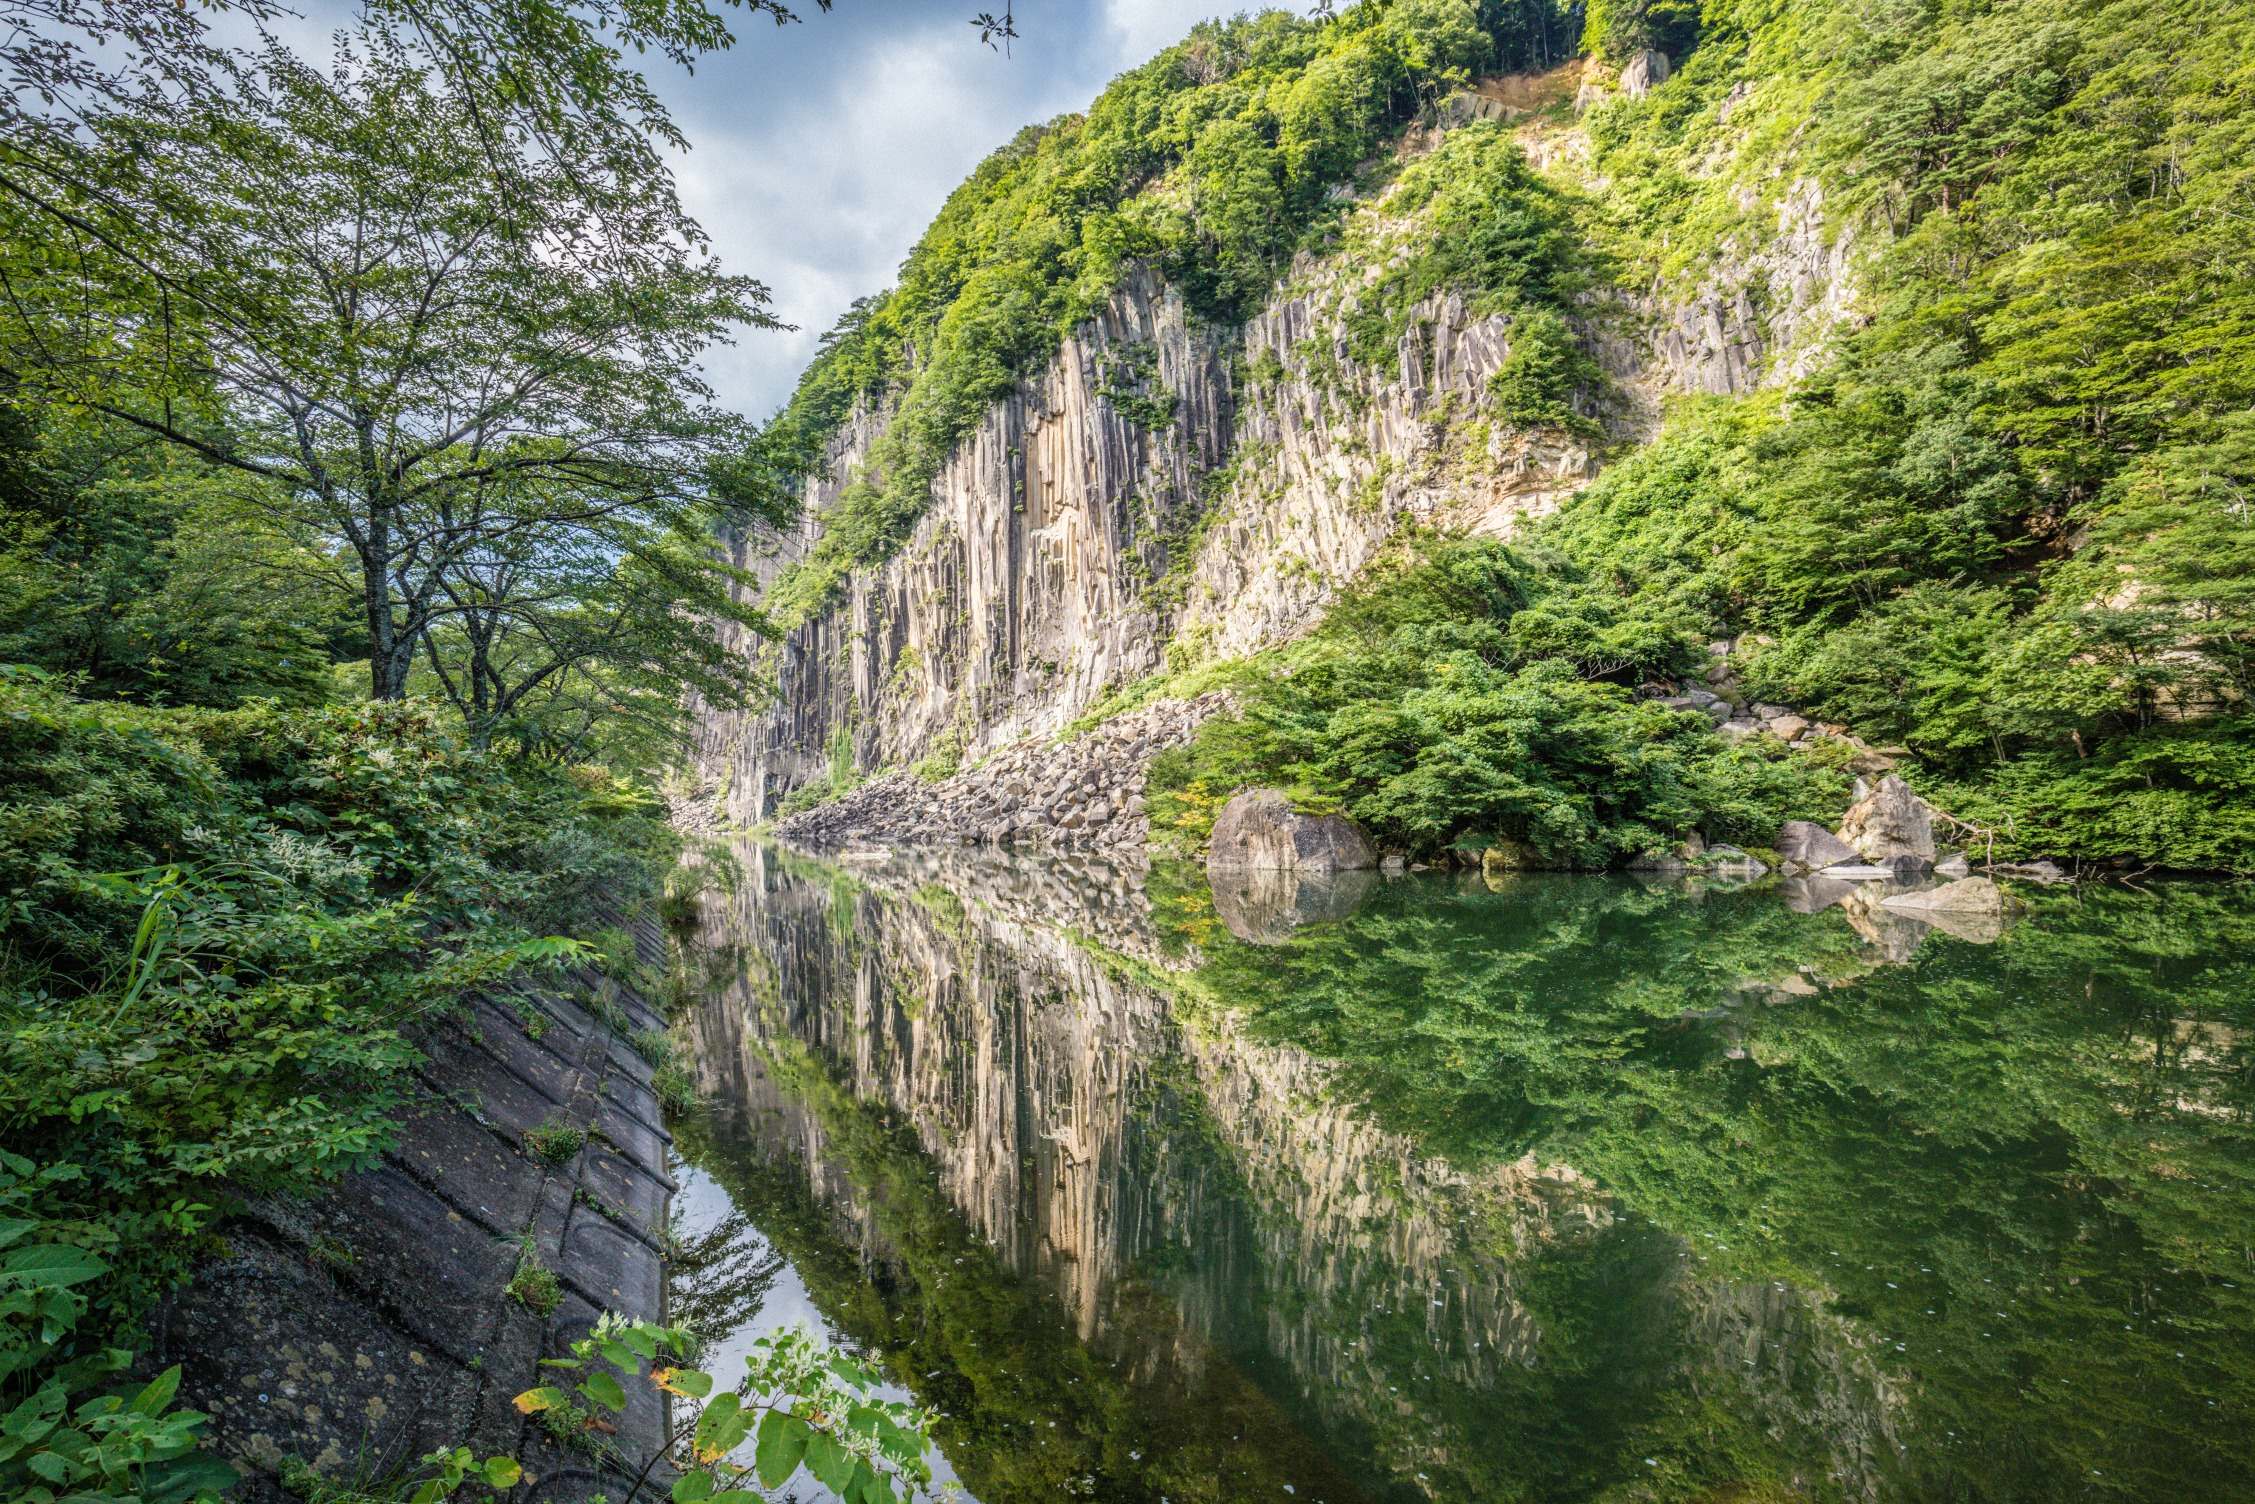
[1536,0,2255,870]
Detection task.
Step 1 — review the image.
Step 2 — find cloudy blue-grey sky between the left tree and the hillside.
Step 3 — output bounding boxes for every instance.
[647,0,1258,417]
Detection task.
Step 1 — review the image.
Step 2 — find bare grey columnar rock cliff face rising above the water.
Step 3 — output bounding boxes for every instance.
[695,113,1851,823]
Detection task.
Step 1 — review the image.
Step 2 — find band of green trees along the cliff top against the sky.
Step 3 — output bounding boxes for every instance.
[755,0,1565,618]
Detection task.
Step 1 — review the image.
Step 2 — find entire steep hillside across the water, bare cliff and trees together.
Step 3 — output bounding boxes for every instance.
[699,0,2255,870]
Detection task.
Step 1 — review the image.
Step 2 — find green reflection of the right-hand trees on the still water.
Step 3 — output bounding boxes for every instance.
[1155,877,2255,1499]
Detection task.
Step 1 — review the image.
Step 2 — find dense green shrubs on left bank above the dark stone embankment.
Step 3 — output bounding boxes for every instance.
[0,670,645,1479]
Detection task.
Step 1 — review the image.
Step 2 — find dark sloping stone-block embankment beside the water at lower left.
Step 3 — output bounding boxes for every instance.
[151,920,674,1504]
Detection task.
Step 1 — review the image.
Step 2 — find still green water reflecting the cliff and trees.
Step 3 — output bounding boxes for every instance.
[683,846,2255,1504]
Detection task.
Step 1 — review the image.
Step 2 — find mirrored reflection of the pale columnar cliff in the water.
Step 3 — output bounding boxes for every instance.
[692,848,1892,1504]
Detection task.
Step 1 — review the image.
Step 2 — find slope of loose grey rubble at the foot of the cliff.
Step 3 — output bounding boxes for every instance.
[776,692,1229,855]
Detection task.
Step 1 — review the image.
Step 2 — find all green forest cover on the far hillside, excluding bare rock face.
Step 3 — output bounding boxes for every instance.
[762,0,2255,870]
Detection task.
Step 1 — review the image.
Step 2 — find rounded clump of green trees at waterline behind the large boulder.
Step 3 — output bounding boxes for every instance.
[1152,539,1847,868]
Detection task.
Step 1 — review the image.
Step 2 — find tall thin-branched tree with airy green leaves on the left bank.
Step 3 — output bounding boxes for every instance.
[0,32,780,699]
